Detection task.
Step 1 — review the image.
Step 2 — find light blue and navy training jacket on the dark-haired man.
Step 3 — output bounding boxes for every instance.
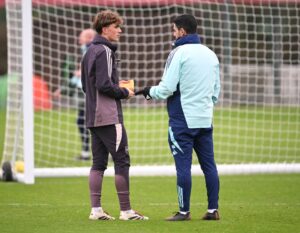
[150,44,220,128]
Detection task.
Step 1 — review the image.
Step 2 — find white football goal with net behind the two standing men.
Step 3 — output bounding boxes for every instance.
[2,0,300,182]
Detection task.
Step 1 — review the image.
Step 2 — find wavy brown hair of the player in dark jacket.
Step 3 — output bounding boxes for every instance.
[93,10,123,34]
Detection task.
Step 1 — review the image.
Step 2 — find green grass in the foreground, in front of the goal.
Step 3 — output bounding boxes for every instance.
[0,174,300,233]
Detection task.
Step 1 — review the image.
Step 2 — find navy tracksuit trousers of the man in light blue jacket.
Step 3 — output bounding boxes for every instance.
[169,127,219,211]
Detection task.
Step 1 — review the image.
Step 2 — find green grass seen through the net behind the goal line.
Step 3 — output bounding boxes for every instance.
[0,107,300,167]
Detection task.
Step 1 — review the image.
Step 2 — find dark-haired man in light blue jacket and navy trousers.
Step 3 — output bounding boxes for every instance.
[135,15,220,221]
